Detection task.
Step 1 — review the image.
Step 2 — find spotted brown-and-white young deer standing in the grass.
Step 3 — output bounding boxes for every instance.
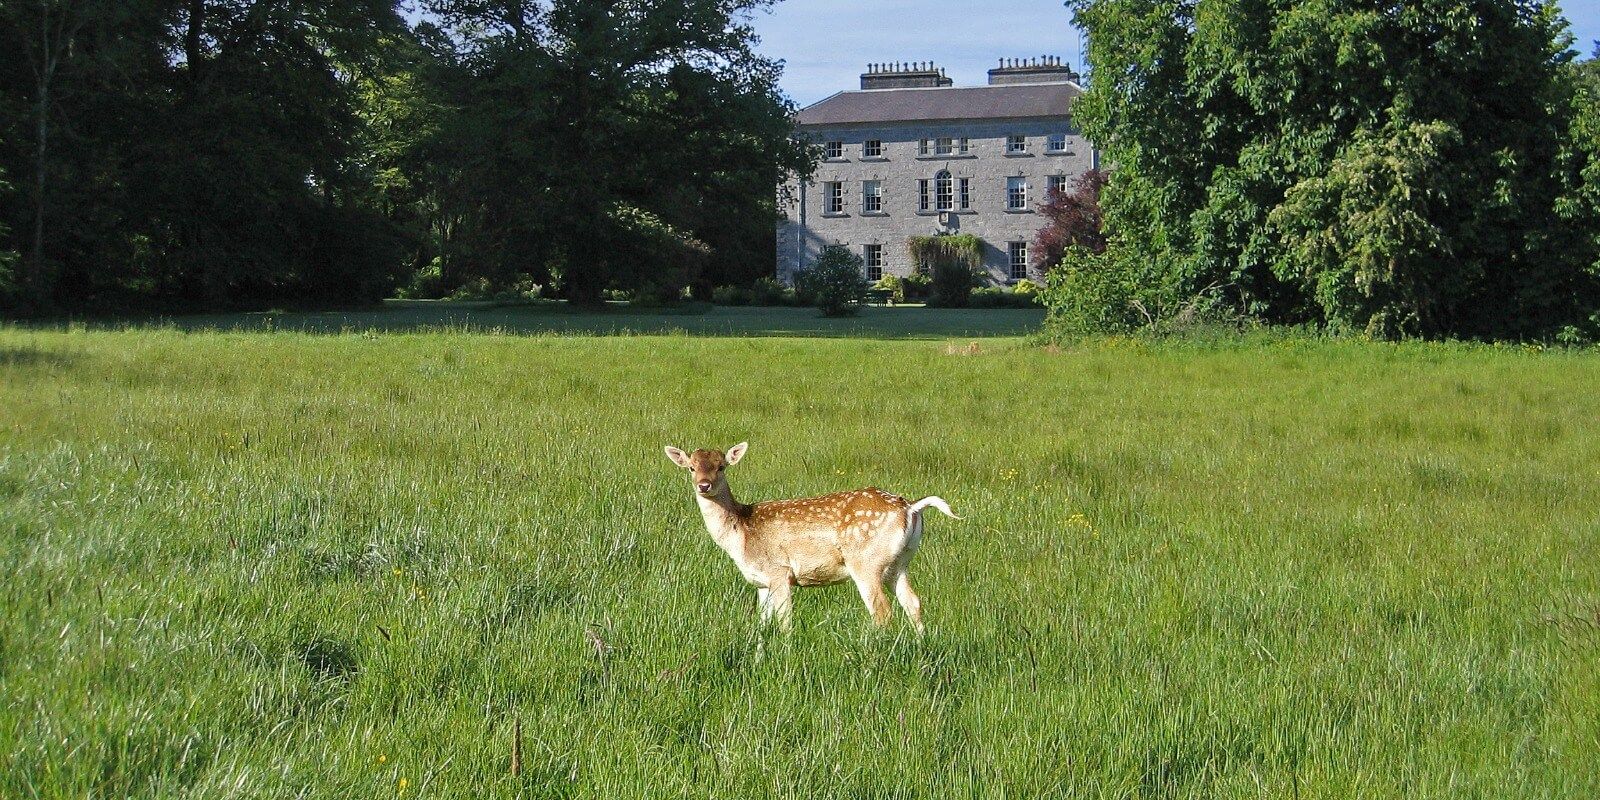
[666,442,960,632]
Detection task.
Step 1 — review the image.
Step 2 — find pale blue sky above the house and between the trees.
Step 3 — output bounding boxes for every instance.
[754,0,1600,106]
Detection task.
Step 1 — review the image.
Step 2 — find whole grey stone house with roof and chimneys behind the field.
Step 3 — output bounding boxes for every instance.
[778,58,1098,283]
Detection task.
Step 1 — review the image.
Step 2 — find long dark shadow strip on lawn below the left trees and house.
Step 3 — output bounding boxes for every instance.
[9,301,1045,339]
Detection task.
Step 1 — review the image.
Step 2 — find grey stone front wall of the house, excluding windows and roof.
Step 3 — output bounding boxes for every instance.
[776,60,1096,283]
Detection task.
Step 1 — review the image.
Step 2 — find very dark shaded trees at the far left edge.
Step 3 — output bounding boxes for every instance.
[0,0,419,310]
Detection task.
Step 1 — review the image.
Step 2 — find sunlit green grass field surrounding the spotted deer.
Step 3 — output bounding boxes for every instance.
[0,308,1600,798]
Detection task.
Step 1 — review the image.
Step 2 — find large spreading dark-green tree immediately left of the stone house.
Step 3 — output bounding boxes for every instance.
[427,0,806,301]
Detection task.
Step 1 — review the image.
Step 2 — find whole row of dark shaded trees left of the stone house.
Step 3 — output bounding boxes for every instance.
[0,0,808,314]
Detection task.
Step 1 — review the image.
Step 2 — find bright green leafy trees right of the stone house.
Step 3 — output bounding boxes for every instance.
[1046,0,1600,341]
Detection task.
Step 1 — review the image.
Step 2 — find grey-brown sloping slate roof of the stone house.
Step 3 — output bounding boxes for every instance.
[795,82,1083,125]
